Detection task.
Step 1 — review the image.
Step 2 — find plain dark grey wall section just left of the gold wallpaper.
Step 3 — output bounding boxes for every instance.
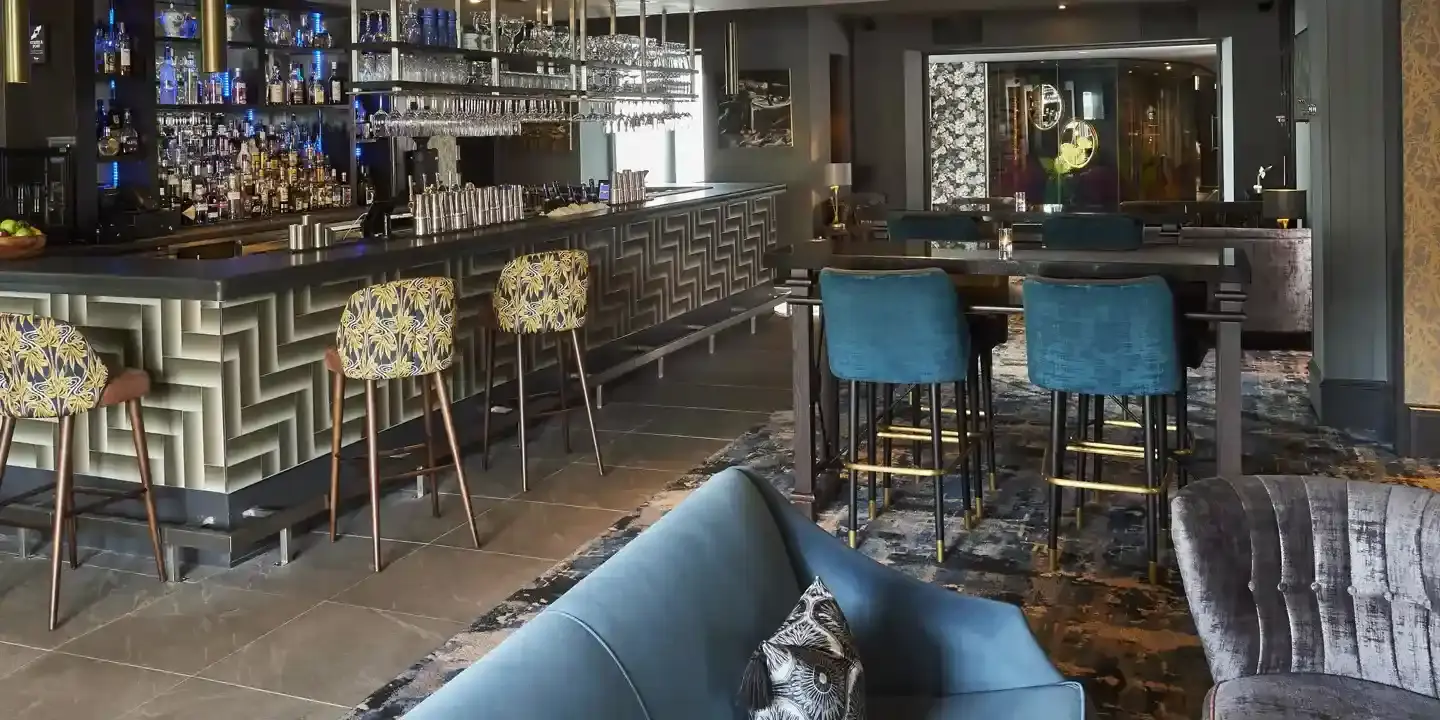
[1305,0,1401,438]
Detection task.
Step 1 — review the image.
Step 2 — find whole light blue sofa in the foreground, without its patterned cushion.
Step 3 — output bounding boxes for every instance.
[406,468,1084,720]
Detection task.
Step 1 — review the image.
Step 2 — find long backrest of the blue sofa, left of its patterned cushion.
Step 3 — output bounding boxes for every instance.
[406,469,801,720]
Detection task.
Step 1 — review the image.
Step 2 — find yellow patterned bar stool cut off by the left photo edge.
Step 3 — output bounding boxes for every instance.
[0,314,166,629]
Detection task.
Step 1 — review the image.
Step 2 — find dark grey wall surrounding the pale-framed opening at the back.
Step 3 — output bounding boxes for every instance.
[845,0,1284,207]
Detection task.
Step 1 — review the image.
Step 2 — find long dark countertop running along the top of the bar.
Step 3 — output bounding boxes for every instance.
[0,183,785,300]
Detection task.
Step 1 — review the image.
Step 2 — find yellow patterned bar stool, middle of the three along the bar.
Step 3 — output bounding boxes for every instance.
[325,278,480,572]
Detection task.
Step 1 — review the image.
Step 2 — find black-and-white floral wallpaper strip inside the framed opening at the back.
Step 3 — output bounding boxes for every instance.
[927,62,989,206]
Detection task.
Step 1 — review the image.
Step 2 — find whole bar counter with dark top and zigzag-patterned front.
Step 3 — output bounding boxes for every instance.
[0,183,785,547]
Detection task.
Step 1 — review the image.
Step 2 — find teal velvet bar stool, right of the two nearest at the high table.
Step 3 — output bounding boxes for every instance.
[1024,276,1184,582]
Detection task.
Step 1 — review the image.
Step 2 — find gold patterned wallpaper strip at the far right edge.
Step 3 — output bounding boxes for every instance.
[1400,0,1440,408]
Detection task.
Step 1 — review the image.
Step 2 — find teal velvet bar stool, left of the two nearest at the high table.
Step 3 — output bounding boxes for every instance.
[819,268,972,562]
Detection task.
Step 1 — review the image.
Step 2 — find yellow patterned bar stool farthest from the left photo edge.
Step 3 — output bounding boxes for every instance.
[480,251,605,491]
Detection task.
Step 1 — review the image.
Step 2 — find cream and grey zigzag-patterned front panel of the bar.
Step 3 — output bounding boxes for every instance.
[0,186,783,492]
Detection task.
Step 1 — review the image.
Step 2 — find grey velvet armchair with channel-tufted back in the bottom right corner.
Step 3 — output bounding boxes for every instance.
[1171,475,1440,720]
